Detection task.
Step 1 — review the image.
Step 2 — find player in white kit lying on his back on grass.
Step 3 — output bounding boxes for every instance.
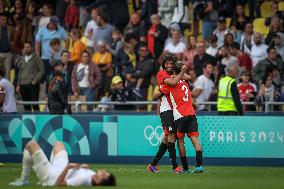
[9,141,115,186]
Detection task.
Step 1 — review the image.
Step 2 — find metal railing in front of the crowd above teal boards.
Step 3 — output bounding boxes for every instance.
[17,101,284,113]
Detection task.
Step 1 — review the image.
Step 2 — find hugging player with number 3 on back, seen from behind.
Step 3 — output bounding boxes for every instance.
[160,62,204,173]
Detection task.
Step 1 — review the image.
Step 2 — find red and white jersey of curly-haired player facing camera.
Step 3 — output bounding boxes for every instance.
[157,70,173,113]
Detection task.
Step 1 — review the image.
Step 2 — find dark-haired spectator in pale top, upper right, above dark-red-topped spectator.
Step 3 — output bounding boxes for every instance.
[240,22,254,55]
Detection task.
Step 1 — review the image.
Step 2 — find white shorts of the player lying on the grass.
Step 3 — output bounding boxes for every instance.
[32,149,69,186]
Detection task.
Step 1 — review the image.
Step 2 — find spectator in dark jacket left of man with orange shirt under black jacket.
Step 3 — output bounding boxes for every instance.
[123,12,143,41]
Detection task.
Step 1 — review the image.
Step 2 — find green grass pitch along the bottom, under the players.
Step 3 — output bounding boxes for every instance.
[0,164,284,189]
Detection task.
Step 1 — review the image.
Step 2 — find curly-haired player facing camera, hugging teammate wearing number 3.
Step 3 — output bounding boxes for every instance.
[147,54,188,173]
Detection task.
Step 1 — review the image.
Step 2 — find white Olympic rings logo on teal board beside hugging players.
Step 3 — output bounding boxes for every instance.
[144,125,164,146]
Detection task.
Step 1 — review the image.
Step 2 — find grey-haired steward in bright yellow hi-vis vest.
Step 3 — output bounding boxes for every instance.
[218,63,243,115]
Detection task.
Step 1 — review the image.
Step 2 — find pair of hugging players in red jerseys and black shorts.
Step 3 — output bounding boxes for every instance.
[147,54,204,173]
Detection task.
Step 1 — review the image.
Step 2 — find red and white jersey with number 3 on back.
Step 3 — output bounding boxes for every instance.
[160,80,195,120]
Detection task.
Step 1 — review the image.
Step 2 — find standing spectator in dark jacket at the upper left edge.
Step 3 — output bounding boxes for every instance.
[0,13,14,80]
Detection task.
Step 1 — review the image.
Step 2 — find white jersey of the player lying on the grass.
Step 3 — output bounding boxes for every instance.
[65,168,96,186]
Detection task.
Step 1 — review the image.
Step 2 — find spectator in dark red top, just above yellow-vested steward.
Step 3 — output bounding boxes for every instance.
[230,44,252,74]
